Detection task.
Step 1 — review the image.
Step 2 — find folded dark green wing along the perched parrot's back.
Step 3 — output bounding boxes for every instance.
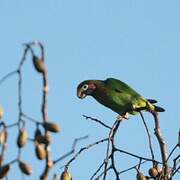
[104,78,140,97]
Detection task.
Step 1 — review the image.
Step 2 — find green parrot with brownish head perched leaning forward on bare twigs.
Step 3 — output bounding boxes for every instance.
[77,78,165,119]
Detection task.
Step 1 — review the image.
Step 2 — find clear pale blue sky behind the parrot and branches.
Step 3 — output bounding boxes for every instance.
[0,0,180,180]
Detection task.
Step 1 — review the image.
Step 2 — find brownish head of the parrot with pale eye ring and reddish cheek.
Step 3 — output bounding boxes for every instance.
[77,80,96,99]
